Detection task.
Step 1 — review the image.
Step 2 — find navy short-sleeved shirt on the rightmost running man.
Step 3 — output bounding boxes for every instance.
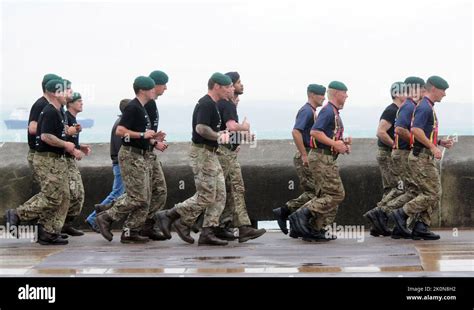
[413,97,438,147]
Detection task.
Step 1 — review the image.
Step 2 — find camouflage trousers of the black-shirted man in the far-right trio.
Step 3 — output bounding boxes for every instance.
[377,148,403,211]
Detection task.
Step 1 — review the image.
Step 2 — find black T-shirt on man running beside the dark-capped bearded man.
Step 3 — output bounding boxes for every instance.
[192,95,221,147]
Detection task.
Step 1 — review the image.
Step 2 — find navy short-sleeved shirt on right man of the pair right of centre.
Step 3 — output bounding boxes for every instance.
[311,102,344,149]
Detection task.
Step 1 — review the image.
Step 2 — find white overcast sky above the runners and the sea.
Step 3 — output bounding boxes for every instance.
[1,0,473,111]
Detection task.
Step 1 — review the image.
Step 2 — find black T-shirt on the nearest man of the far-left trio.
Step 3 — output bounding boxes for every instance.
[36,104,66,155]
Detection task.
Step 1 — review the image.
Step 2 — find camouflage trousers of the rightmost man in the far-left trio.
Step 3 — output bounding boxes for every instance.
[66,158,84,218]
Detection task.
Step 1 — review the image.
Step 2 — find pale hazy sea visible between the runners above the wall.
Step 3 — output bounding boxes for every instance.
[0,100,474,143]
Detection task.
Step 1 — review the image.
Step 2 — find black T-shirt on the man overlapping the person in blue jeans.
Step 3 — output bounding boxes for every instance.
[119,98,151,150]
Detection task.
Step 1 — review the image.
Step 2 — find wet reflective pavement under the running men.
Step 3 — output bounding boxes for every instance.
[0,230,474,277]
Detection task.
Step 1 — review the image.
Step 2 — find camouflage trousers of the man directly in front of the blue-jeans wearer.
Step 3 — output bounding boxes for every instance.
[105,146,151,231]
